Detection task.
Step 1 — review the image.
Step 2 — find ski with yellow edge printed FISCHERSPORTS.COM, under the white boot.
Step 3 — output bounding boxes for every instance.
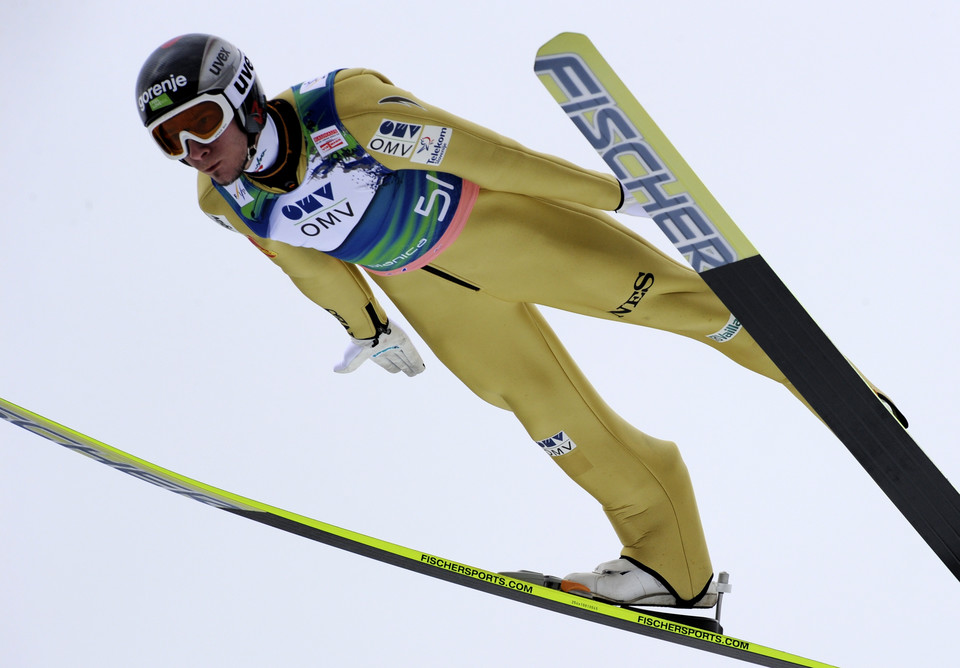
[0,398,830,668]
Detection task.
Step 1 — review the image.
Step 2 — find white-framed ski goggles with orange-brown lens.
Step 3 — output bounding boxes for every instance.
[147,93,233,160]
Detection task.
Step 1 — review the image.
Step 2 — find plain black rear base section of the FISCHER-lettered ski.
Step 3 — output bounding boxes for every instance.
[700,255,960,579]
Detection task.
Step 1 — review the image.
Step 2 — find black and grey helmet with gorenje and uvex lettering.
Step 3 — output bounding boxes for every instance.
[137,34,266,154]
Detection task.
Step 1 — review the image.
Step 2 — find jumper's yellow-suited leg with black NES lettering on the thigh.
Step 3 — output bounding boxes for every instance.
[434,191,796,394]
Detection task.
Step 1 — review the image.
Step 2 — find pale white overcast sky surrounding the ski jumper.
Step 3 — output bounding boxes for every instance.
[0,0,960,668]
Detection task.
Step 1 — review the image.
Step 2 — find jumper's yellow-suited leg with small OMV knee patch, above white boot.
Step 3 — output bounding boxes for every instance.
[374,267,712,600]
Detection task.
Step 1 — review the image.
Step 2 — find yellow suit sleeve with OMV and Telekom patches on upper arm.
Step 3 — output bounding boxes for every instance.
[334,69,621,211]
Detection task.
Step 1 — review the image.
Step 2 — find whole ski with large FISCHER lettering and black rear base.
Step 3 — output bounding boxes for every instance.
[534,33,960,579]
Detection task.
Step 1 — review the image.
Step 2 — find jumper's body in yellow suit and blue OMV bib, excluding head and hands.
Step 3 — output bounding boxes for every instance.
[199,69,792,601]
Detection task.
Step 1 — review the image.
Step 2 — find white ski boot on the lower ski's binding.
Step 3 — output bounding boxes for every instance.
[561,558,717,608]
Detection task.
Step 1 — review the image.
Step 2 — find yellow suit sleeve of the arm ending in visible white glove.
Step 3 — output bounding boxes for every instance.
[198,174,387,339]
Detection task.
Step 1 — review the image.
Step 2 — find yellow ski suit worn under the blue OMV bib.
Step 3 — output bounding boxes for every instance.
[199,69,789,601]
